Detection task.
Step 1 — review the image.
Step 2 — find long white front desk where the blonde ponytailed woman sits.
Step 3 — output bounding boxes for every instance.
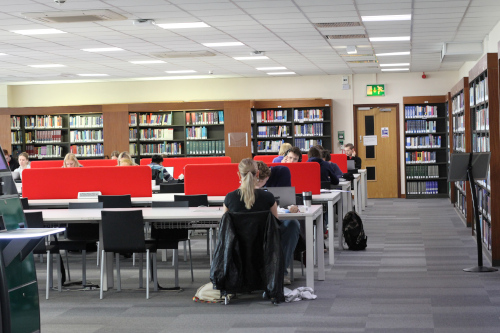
[36,205,325,290]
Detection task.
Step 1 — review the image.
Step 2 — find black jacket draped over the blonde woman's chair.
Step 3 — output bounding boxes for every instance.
[210,211,285,302]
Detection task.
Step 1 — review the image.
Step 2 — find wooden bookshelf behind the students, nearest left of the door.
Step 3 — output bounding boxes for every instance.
[250,99,333,155]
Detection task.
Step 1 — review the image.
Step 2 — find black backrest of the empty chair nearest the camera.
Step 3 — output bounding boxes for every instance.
[101,210,146,253]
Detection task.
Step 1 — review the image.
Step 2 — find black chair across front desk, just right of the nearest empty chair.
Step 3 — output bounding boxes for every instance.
[147,201,194,288]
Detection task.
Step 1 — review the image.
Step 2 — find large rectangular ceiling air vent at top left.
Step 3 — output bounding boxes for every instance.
[21,9,127,23]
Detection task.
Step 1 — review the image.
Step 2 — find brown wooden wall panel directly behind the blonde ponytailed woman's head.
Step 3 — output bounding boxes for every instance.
[224,101,252,163]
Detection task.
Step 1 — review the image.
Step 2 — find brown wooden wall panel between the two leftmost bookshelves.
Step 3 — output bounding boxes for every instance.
[102,104,128,156]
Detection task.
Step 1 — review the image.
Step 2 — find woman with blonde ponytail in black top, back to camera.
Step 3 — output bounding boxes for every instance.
[224,158,299,284]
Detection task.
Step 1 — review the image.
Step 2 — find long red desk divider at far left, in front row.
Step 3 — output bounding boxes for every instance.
[23,166,152,200]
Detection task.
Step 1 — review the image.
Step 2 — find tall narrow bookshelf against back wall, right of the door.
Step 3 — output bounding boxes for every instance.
[403,95,448,199]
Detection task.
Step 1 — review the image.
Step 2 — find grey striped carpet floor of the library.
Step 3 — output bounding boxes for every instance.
[37,199,500,333]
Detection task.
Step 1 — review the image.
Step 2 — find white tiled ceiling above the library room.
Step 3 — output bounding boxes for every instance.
[0,0,500,84]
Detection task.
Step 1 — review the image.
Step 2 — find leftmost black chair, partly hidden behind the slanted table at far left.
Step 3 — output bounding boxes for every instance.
[24,212,62,299]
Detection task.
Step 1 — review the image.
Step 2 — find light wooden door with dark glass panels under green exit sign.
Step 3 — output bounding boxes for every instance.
[354,105,400,198]
